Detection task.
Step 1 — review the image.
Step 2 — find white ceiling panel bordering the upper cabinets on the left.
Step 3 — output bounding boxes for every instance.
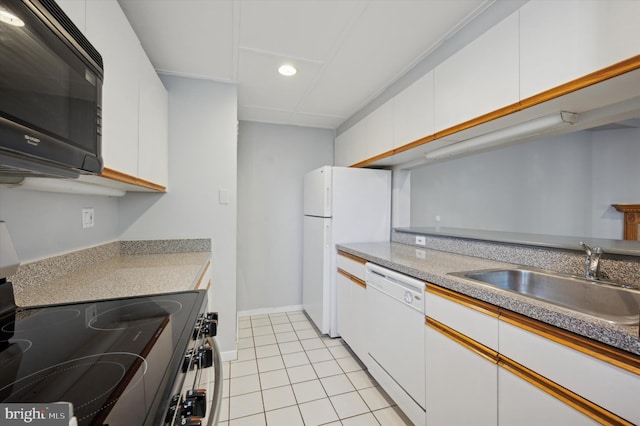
[119,0,234,81]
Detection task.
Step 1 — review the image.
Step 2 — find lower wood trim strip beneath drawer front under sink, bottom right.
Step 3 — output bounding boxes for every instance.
[498,355,633,425]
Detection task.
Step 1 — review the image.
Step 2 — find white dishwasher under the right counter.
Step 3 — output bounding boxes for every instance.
[366,263,426,425]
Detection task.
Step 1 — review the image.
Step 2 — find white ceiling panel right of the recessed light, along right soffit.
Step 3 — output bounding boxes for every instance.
[301,0,485,115]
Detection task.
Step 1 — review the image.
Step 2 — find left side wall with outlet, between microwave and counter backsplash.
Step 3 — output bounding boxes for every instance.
[0,188,118,263]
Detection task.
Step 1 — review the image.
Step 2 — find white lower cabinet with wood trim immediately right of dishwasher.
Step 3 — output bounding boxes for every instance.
[425,284,498,426]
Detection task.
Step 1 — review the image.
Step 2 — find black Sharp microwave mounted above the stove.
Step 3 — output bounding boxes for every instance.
[0,0,104,179]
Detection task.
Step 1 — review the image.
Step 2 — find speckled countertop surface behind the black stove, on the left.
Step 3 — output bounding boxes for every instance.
[14,252,210,306]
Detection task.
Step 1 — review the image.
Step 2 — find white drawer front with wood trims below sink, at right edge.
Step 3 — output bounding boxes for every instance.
[500,313,640,424]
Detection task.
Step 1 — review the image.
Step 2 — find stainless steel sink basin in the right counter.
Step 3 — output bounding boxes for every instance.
[450,268,640,325]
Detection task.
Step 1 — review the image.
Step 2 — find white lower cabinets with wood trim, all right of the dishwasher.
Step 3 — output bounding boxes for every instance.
[425,284,640,426]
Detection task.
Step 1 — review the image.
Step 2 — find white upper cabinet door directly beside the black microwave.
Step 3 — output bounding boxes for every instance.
[86,0,143,176]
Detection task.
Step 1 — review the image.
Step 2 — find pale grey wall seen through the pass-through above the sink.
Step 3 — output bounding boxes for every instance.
[411,129,640,239]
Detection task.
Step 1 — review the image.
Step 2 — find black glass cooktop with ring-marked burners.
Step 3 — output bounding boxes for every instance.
[0,291,205,426]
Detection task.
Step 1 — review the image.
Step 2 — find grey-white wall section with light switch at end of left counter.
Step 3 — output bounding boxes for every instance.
[119,76,237,352]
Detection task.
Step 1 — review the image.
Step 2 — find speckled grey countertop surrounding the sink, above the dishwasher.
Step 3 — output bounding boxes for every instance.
[338,242,640,355]
